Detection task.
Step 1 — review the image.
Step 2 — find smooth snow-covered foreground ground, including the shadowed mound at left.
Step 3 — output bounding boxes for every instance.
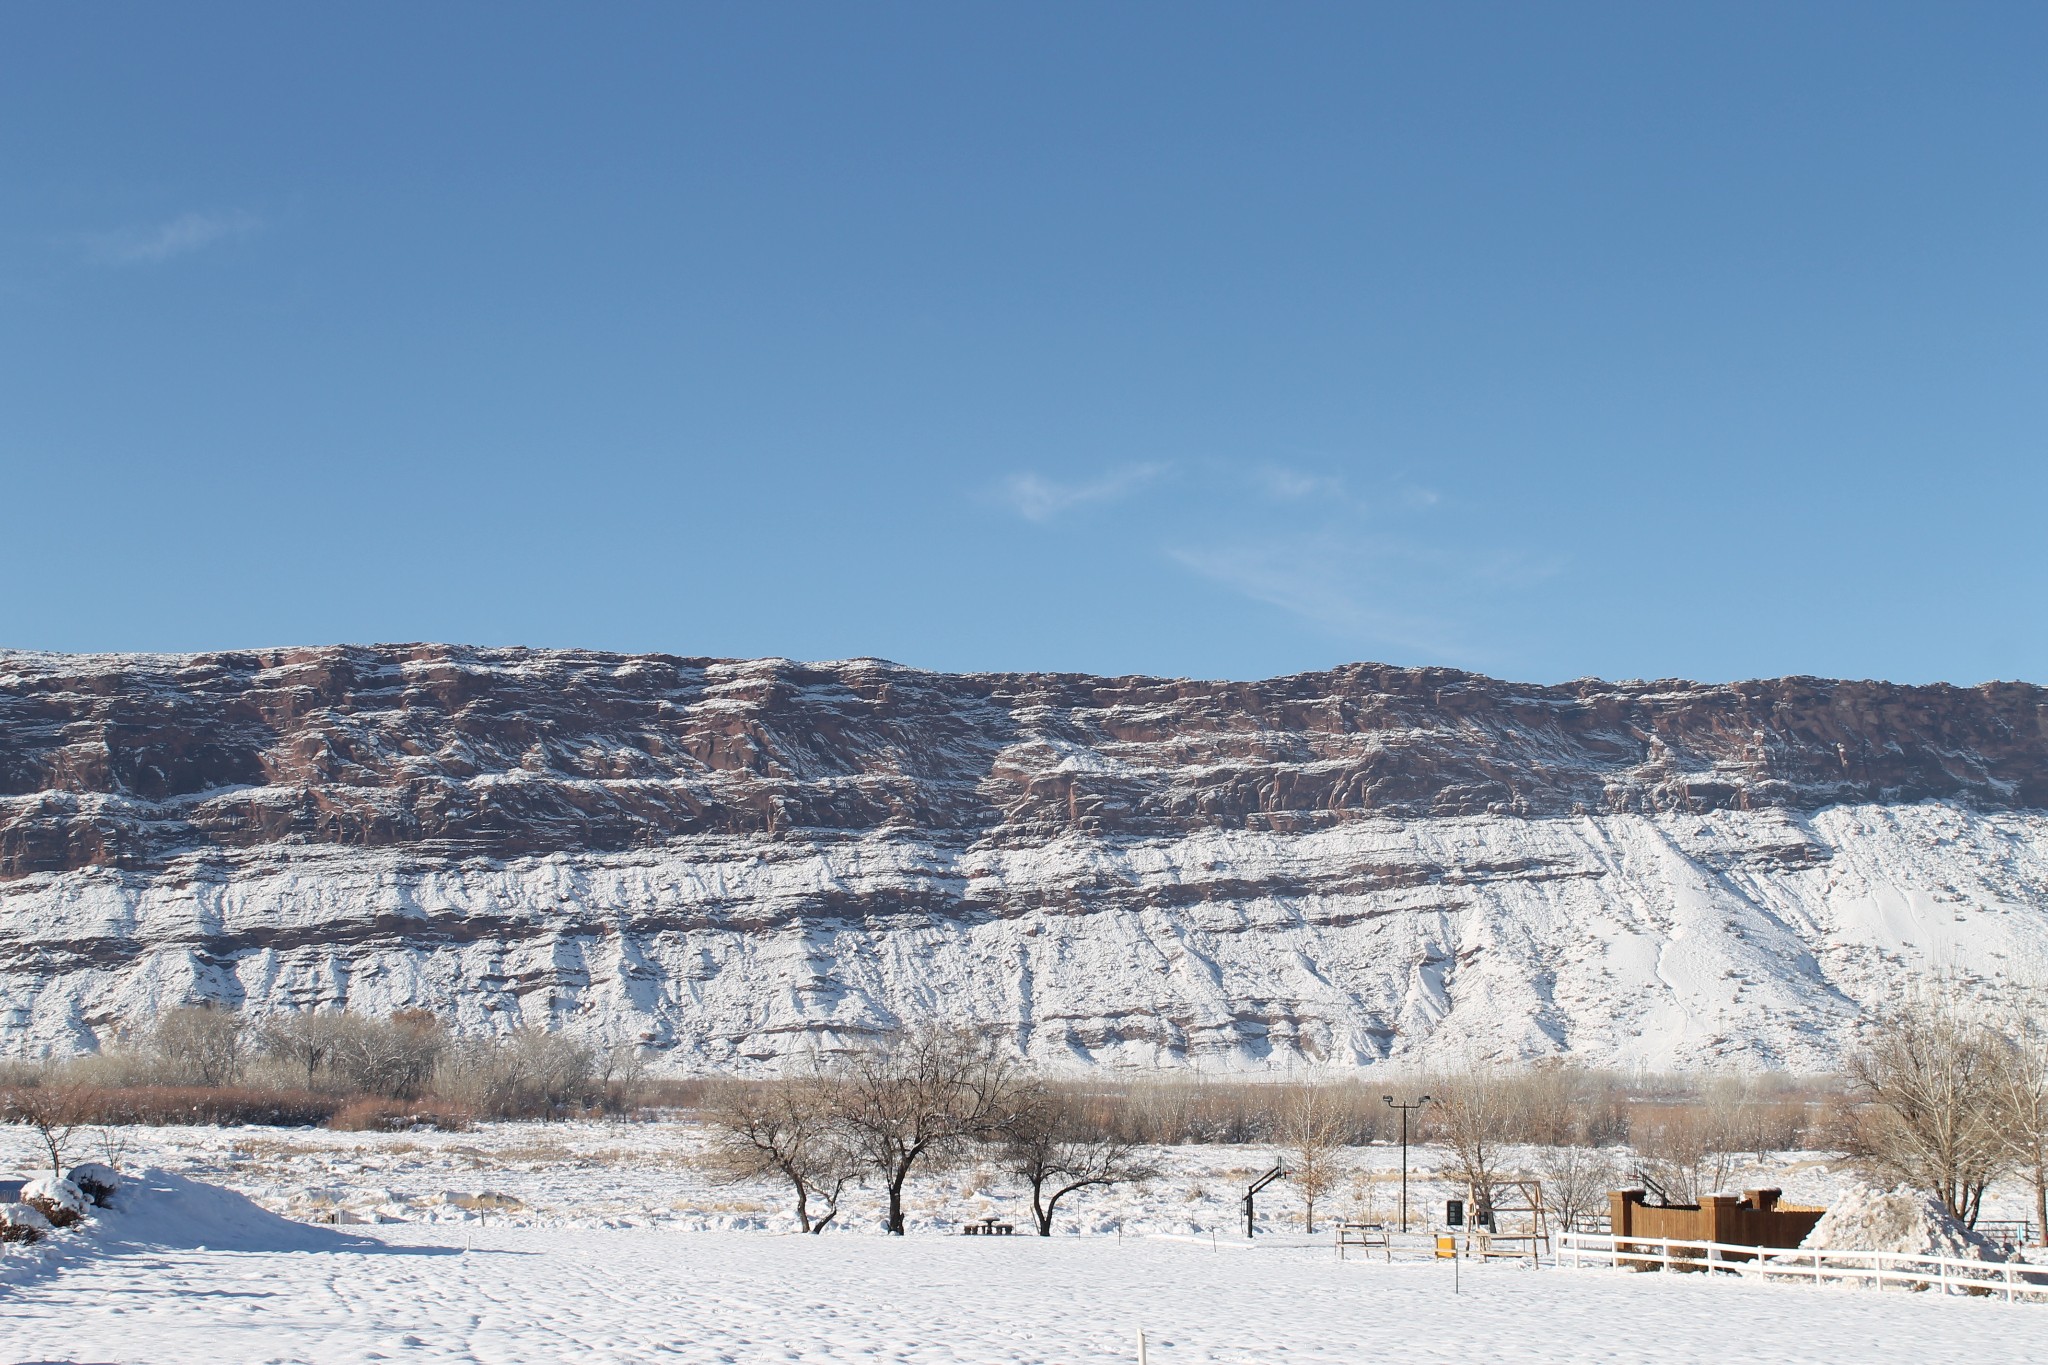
[0,1171,2048,1365]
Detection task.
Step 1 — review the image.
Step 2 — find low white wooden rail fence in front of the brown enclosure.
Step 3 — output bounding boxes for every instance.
[1556,1232,2048,1304]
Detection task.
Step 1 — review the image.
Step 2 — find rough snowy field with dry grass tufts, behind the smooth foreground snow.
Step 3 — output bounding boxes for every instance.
[12,1124,1933,1238]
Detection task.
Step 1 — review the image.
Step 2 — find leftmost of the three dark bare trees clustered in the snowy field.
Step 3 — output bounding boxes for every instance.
[707,1076,854,1232]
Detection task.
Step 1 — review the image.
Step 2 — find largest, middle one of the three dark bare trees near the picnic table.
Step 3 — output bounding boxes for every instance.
[831,1025,1020,1236]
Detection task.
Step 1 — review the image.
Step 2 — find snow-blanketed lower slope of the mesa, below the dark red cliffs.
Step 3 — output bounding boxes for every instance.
[0,802,2048,1070]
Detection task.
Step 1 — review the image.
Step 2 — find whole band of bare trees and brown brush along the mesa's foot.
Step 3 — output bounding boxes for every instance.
[0,980,2048,1234]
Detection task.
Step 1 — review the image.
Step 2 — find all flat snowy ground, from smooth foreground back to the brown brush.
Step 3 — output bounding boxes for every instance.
[12,1124,2048,1365]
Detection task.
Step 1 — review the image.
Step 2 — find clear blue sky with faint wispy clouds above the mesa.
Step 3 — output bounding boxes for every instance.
[0,0,2048,684]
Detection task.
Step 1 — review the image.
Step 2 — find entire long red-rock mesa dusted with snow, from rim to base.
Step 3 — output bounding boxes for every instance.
[0,647,2048,1072]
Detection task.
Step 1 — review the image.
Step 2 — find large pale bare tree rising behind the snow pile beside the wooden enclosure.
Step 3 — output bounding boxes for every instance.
[1849,980,2011,1226]
